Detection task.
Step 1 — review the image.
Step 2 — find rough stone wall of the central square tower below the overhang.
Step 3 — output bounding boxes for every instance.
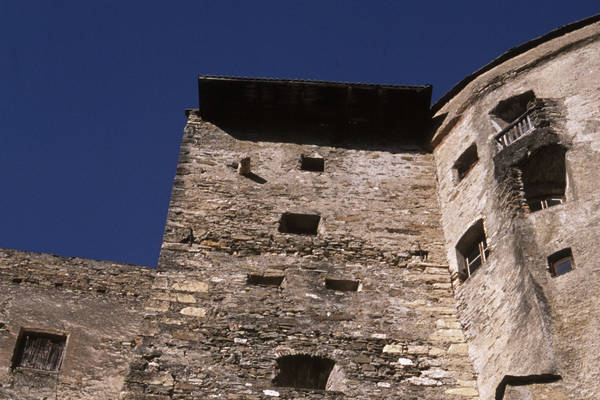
[119,112,477,399]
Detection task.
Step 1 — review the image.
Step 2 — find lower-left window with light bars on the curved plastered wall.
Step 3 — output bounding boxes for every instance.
[456,220,489,281]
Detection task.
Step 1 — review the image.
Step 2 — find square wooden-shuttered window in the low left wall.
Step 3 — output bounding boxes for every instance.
[12,330,67,371]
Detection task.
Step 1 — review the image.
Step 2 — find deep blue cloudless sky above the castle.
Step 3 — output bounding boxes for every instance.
[0,0,600,266]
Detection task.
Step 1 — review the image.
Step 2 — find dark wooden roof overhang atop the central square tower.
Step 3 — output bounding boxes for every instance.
[198,76,431,145]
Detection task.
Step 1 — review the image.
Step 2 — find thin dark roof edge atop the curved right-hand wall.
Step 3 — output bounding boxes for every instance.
[431,14,600,115]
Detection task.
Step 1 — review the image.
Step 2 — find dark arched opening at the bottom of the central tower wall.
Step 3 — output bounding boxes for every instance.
[273,354,335,390]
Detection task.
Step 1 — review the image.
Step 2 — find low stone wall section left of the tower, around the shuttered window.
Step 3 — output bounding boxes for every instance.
[0,250,153,400]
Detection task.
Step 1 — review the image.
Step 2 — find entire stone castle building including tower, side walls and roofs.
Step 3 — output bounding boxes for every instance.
[0,16,600,400]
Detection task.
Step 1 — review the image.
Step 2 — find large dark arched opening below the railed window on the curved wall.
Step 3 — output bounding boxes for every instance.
[521,145,567,212]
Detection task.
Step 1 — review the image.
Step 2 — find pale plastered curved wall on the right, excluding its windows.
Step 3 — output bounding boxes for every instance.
[433,23,600,399]
